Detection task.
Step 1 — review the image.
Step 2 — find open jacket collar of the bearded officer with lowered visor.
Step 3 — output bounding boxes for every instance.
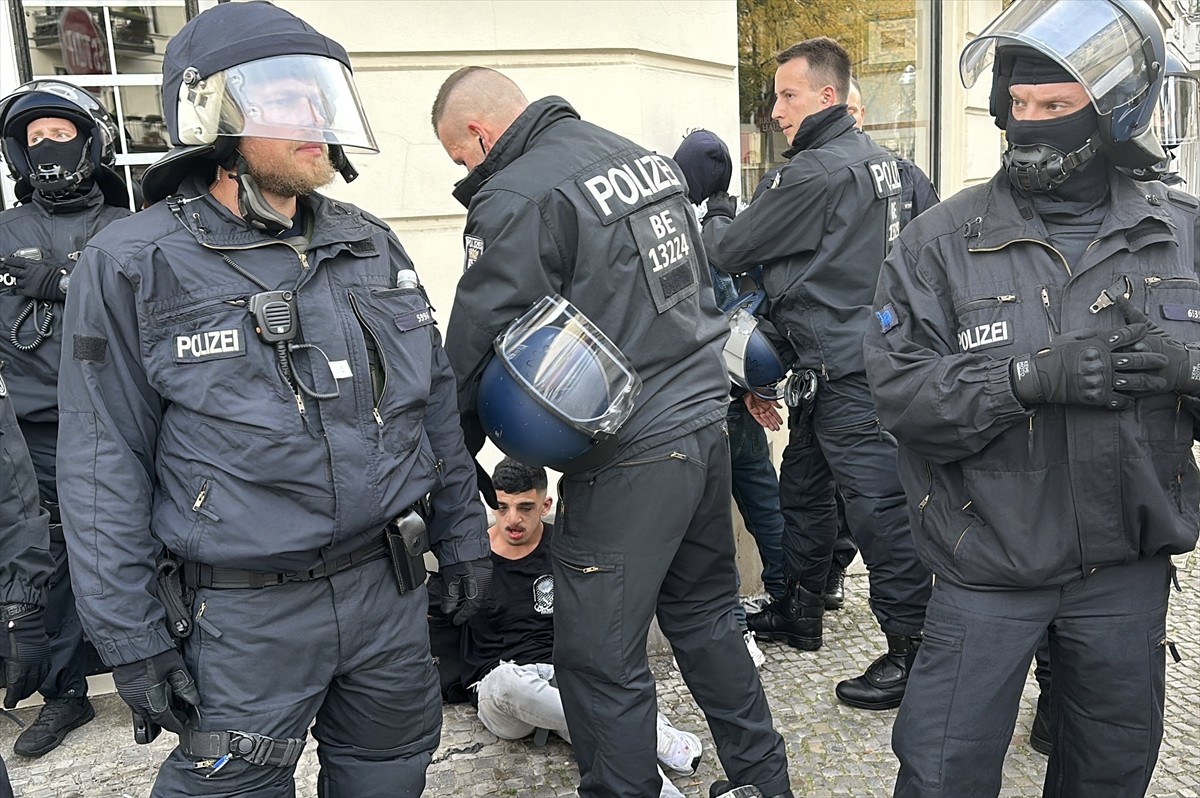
[171,175,378,250]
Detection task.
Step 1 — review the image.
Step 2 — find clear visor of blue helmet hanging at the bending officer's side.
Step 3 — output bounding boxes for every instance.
[496,296,642,436]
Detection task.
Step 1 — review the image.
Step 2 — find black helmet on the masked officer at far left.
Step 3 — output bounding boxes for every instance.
[0,80,130,208]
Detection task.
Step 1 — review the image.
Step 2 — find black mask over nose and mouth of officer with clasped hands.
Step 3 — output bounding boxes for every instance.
[1004,104,1104,194]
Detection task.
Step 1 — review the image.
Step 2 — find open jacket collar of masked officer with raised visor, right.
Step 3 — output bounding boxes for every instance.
[962,167,1174,251]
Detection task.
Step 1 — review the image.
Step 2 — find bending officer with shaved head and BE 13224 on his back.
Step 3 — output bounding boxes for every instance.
[432,67,791,798]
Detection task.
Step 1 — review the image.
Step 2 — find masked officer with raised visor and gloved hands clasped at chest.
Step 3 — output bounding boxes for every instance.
[865,0,1200,798]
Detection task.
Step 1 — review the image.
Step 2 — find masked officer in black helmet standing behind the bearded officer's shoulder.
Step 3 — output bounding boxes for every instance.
[0,80,130,756]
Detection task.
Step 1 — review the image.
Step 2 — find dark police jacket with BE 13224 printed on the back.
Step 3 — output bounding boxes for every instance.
[446,97,730,463]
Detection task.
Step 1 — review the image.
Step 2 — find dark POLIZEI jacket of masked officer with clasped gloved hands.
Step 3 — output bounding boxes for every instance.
[864,169,1200,589]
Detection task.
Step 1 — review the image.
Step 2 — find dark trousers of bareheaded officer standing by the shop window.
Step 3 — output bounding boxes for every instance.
[779,373,931,636]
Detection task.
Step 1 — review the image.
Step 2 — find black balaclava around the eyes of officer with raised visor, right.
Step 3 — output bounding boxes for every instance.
[1004,54,1108,205]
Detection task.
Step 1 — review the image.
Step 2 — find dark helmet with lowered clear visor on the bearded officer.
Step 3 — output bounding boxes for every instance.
[143,0,378,204]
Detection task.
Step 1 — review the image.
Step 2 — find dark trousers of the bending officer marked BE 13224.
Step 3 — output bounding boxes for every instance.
[553,422,788,798]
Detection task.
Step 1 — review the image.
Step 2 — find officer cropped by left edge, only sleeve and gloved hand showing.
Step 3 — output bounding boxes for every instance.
[0,367,54,798]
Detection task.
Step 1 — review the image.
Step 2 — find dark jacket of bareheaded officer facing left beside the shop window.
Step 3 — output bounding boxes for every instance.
[706,104,901,379]
